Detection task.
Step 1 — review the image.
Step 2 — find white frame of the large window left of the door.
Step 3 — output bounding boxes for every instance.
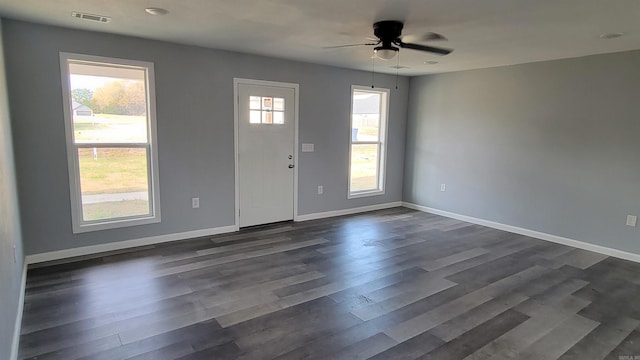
[60,52,161,234]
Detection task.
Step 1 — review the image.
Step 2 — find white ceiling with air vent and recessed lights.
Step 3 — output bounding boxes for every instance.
[0,0,640,75]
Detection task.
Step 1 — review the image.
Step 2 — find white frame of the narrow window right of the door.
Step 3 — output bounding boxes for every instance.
[347,85,391,199]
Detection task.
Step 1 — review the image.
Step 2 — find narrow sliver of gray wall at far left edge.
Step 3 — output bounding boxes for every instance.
[0,18,24,359]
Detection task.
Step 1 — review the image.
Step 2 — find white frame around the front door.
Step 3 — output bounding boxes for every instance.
[233,77,300,231]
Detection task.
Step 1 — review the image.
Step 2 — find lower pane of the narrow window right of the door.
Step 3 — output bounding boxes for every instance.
[350,144,379,192]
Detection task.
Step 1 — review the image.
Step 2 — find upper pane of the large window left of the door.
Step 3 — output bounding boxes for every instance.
[69,63,147,143]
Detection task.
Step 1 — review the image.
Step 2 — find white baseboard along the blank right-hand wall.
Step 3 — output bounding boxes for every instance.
[402,202,640,263]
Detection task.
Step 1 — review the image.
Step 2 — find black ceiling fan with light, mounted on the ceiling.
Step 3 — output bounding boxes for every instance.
[328,20,453,60]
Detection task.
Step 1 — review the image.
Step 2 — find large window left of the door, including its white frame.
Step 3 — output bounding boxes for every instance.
[60,53,160,233]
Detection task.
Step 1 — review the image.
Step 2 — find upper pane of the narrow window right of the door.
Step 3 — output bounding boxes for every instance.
[351,91,381,141]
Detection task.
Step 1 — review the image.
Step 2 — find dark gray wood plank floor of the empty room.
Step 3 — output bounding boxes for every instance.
[20,208,640,360]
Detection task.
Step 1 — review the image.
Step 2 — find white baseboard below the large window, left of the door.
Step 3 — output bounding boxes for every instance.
[26,225,238,264]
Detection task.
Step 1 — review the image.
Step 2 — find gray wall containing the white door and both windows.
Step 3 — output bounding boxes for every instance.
[4,20,408,254]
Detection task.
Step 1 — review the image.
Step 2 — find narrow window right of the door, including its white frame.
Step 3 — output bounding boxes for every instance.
[349,86,389,198]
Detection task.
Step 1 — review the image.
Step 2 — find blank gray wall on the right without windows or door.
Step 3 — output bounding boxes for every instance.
[403,51,640,254]
